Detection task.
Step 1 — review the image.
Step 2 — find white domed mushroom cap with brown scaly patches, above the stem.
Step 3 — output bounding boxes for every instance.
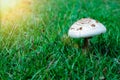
[68,18,106,38]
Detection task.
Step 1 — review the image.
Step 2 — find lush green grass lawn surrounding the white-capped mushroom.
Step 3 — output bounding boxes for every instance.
[0,0,120,80]
